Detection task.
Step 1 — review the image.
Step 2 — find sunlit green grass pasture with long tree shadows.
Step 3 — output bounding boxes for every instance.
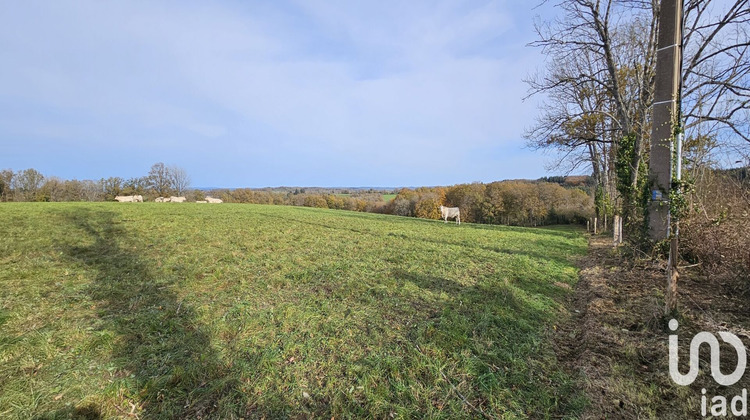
[0,203,586,419]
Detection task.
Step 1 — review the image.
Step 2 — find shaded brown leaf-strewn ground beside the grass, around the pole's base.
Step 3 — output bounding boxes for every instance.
[555,236,750,419]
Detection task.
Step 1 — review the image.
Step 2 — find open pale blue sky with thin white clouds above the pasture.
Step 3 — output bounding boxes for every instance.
[0,0,551,188]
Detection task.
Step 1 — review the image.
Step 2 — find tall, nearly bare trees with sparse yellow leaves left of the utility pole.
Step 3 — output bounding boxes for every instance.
[526,0,658,220]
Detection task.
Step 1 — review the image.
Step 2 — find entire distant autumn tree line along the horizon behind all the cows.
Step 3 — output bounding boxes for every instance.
[0,166,593,226]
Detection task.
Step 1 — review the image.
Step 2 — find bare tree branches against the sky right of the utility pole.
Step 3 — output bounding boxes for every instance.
[682,0,750,158]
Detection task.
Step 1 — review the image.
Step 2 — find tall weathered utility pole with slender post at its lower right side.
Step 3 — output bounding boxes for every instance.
[648,0,683,312]
